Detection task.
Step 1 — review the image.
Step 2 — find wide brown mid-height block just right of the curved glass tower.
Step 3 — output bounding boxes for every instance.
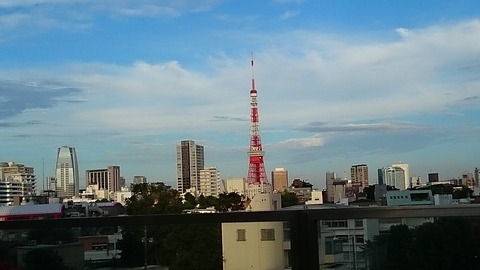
[85,166,121,192]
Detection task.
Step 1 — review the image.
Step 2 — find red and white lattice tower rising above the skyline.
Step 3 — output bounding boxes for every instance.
[247,56,271,197]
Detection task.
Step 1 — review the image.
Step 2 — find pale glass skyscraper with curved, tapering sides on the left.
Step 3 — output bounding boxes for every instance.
[55,146,80,198]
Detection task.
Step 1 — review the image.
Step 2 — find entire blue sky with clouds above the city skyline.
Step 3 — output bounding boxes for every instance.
[0,0,480,190]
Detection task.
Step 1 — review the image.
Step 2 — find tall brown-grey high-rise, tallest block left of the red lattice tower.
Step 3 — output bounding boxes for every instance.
[177,140,205,194]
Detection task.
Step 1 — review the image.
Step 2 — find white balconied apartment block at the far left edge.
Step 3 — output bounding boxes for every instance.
[0,162,36,205]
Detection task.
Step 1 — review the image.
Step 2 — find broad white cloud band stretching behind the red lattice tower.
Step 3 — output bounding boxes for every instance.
[4,21,480,158]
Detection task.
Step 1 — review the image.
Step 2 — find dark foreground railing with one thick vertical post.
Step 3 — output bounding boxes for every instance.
[0,205,480,270]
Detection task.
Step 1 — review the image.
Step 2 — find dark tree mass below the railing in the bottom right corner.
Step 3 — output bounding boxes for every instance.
[365,217,480,270]
